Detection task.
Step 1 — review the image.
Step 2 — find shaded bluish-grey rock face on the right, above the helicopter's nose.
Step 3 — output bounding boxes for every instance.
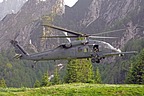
[63,0,144,47]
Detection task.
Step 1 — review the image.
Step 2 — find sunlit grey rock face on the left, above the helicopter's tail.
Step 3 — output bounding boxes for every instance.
[0,0,64,49]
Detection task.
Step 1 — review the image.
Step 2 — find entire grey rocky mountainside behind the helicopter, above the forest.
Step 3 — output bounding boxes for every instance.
[0,0,144,50]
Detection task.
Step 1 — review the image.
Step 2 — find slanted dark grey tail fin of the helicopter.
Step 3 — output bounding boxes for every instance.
[10,40,28,57]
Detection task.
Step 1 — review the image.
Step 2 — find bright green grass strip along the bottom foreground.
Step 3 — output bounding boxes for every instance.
[0,83,144,96]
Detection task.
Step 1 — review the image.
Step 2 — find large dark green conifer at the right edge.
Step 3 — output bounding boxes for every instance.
[126,49,144,84]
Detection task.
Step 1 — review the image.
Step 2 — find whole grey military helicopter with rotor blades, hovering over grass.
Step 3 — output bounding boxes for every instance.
[10,24,137,63]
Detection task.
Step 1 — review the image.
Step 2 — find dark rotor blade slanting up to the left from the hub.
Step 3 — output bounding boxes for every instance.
[43,24,84,36]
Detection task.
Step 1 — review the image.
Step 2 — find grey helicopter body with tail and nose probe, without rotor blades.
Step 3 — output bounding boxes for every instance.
[10,40,137,63]
